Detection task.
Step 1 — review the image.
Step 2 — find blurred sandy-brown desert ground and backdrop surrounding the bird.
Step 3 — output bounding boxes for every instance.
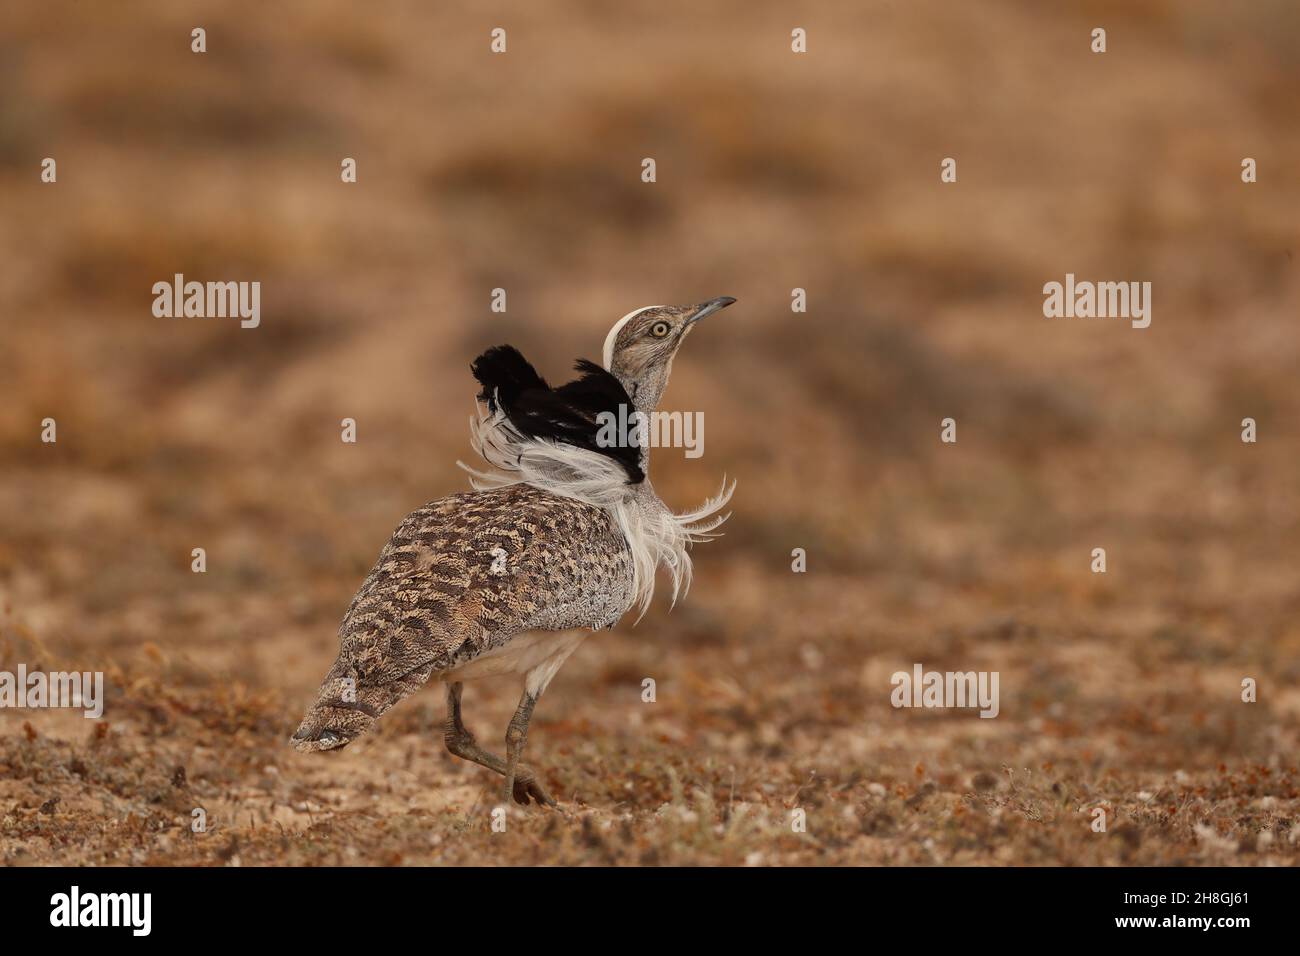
[0,0,1300,864]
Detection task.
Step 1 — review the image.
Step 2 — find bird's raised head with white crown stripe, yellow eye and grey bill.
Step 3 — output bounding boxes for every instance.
[605,295,736,412]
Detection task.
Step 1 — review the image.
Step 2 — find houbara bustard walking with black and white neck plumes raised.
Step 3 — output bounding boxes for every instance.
[293,297,735,805]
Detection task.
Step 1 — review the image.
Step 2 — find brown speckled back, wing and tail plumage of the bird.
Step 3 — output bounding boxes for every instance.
[299,485,632,749]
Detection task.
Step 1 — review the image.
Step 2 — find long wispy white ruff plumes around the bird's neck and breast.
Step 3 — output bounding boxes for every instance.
[456,395,736,620]
